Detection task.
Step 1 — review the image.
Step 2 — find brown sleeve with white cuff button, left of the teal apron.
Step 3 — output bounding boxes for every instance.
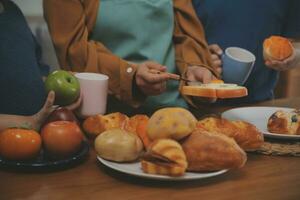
[43,0,138,106]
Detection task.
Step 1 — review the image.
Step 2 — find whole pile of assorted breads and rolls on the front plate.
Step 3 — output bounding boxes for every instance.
[83,108,263,176]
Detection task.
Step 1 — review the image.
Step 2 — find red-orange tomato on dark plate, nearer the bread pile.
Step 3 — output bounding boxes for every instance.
[41,121,83,158]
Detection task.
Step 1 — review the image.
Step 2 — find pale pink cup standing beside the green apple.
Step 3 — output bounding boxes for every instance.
[75,72,109,118]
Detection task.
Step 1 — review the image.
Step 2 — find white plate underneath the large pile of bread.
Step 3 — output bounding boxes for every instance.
[97,156,228,181]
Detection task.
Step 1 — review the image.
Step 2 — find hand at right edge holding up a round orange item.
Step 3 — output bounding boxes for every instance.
[265,49,300,71]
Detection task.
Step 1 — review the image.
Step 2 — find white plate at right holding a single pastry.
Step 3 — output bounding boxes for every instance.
[222,107,300,140]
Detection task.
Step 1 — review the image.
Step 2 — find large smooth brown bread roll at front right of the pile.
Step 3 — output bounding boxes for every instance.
[181,129,247,172]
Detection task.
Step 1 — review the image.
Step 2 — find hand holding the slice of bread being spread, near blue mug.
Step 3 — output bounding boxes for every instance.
[186,66,217,103]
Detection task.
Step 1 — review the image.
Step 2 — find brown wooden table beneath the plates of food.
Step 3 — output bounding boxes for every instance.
[0,98,300,200]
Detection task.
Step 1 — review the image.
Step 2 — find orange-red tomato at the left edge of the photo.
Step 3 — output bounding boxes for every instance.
[0,128,42,160]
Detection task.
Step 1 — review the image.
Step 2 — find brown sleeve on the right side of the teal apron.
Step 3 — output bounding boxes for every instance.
[173,0,220,106]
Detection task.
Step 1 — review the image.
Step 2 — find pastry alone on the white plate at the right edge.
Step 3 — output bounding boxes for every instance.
[268,110,300,135]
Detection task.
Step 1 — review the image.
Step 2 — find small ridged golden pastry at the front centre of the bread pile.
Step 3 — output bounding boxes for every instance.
[141,139,187,176]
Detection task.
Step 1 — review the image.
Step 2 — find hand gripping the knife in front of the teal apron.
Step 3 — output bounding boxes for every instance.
[135,61,169,96]
